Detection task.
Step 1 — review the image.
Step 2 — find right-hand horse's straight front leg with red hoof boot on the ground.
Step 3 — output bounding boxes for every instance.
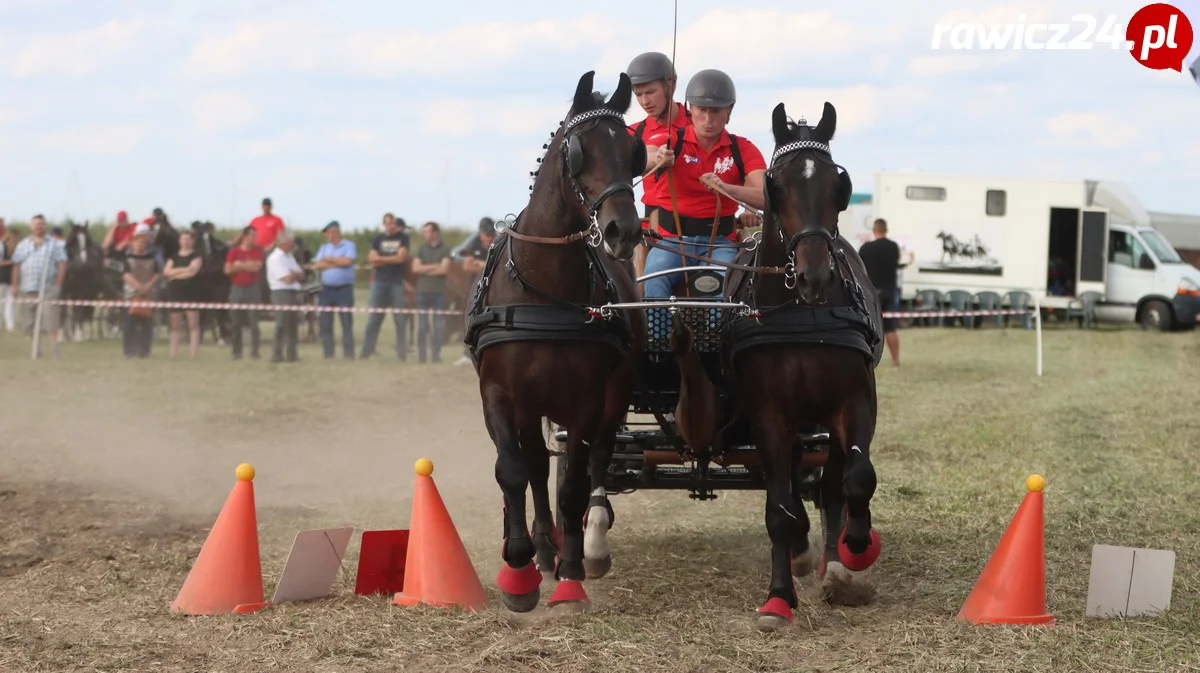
[755,409,808,631]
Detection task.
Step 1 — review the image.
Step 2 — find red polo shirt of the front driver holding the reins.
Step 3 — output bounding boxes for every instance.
[662,126,767,220]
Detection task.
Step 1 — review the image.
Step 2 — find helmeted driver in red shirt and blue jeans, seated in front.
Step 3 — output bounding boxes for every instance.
[643,70,767,324]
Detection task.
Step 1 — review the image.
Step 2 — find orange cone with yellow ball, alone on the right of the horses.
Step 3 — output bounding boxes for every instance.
[959,474,1055,626]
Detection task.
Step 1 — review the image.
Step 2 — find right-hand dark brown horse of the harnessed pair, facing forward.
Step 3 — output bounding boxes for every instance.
[676,103,883,630]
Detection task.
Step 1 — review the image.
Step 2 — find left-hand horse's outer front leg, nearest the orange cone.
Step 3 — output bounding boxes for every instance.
[484,387,541,612]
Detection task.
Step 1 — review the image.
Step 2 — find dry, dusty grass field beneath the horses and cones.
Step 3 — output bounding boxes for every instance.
[0,316,1200,672]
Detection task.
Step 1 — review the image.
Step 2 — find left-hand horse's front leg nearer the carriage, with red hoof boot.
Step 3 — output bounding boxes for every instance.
[547,423,598,614]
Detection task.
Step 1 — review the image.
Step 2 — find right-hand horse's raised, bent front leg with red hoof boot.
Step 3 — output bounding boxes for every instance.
[817,388,880,606]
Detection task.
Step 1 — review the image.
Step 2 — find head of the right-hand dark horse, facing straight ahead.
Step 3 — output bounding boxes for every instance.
[763,102,853,302]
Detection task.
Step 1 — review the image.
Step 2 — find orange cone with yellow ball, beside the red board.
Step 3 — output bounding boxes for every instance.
[391,458,487,611]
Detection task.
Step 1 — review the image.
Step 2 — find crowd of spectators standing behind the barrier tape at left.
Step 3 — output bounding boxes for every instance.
[0,199,496,363]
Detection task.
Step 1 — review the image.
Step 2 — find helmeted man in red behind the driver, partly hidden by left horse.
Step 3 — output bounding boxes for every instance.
[625,52,690,283]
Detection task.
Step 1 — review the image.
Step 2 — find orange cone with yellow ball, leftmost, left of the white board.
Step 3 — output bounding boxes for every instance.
[170,463,269,614]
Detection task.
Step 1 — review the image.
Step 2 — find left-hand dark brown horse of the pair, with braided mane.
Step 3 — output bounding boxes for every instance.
[464,72,646,612]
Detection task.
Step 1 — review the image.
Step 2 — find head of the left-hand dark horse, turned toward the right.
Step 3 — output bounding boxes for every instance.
[533,71,646,262]
